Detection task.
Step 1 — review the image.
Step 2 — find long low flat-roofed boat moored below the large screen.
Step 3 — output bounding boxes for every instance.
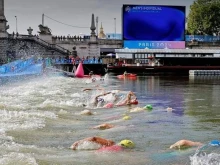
[107,49,220,74]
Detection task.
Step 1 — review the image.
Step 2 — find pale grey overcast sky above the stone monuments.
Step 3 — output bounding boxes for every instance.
[4,0,193,36]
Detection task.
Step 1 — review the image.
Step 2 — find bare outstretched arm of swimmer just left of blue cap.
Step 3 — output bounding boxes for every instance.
[170,140,203,149]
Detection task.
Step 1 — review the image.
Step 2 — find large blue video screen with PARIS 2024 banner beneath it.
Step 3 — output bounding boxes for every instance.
[122,5,186,49]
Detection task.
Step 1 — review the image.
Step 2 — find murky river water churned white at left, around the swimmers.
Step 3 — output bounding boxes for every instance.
[0,75,220,165]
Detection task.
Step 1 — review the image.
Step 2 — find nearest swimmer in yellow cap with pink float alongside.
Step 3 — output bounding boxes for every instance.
[70,137,135,151]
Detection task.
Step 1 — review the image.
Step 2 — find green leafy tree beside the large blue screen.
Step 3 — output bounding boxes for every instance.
[187,0,220,35]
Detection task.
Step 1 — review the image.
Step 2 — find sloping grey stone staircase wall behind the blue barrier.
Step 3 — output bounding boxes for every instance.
[0,35,70,64]
